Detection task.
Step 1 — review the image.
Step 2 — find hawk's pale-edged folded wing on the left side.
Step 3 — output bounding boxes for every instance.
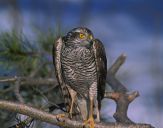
[53,37,80,119]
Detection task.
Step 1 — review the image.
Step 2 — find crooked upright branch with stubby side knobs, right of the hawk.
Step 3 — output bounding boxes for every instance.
[105,54,139,123]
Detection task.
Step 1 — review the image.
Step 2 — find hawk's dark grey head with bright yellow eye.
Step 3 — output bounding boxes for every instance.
[64,27,94,48]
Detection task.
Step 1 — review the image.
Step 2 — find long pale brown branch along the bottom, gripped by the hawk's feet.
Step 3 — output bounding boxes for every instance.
[0,100,153,128]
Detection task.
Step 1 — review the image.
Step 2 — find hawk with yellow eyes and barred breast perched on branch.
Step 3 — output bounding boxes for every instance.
[53,27,107,128]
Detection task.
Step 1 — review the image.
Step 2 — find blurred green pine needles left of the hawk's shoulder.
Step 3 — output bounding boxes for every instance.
[0,31,60,76]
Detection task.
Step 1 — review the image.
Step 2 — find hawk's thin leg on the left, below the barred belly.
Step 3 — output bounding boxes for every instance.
[68,88,77,118]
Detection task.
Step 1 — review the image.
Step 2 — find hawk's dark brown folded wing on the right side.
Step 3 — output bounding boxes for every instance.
[93,39,107,100]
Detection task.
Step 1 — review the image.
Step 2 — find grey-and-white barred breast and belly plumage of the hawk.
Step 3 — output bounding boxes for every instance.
[61,47,97,95]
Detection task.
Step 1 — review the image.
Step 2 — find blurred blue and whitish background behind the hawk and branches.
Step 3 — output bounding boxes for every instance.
[0,0,163,128]
